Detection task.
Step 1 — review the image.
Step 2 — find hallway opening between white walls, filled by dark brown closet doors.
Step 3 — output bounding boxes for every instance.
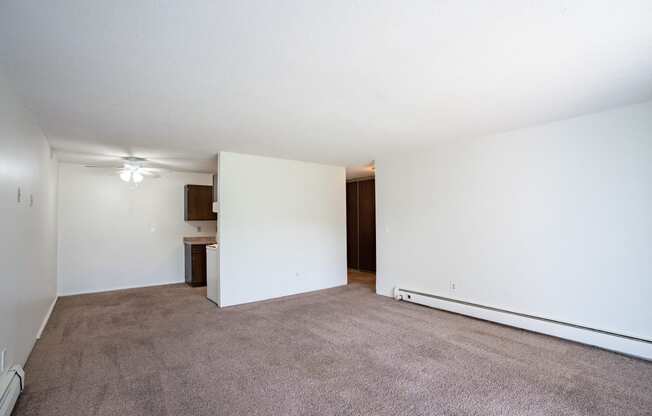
[346,177,376,288]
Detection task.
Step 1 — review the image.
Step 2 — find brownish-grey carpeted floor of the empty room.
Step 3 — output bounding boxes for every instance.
[14,284,652,416]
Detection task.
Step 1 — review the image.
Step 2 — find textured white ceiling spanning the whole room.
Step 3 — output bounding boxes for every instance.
[0,0,652,169]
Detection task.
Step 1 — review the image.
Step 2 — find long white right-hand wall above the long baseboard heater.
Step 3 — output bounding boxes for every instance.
[376,102,652,339]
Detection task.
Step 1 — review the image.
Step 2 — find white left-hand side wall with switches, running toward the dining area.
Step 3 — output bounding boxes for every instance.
[0,73,57,366]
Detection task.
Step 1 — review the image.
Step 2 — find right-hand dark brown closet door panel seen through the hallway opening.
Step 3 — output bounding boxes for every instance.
[358,179,376,271]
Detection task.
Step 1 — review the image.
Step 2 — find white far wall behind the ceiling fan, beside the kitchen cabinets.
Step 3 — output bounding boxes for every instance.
[58,163,216,295]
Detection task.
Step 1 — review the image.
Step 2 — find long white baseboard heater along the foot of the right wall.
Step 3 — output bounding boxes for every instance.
[394,287,652,360]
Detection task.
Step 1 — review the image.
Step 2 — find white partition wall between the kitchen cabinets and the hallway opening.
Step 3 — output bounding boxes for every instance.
[218,152,347,306]
